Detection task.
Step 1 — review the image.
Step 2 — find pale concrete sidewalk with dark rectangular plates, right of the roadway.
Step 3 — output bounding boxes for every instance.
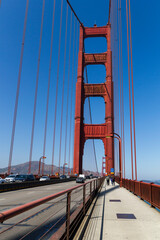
[83,182,160,240]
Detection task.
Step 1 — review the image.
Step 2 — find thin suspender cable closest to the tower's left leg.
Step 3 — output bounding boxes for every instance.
[68,18,75,172]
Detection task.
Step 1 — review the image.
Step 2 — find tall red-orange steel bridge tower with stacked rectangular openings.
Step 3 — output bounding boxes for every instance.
[73,24,114,174]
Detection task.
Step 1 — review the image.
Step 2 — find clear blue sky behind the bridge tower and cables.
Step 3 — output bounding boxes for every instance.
[0,0,160,180]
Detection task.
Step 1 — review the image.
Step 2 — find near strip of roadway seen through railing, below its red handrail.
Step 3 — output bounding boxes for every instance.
[0,182,90,240]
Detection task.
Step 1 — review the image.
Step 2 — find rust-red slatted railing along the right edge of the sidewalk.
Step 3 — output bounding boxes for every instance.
[115,177,160,209]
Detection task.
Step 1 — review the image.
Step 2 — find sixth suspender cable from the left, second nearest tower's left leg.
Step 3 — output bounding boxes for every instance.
[64,11,72,172]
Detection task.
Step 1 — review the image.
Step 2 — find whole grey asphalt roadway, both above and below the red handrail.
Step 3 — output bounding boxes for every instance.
[0,181,89,240]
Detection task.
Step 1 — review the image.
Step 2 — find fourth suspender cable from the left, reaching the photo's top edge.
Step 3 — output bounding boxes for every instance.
[52,0,63,174]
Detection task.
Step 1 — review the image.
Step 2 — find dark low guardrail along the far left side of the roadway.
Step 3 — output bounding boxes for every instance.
[0,178,76,193]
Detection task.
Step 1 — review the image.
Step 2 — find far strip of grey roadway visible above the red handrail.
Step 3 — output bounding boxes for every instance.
[0,180,91,212]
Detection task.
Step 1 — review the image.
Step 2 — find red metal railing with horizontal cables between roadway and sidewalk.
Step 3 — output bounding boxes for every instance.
[0,177,105,239]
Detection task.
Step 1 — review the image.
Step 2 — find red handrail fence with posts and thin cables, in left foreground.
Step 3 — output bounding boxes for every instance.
[0,178,105,239]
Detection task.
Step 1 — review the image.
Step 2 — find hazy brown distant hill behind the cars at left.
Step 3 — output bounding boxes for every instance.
[0,161,96,175]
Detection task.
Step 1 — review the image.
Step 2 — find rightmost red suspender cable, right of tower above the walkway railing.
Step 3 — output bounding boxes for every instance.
[129,0,137,180]
